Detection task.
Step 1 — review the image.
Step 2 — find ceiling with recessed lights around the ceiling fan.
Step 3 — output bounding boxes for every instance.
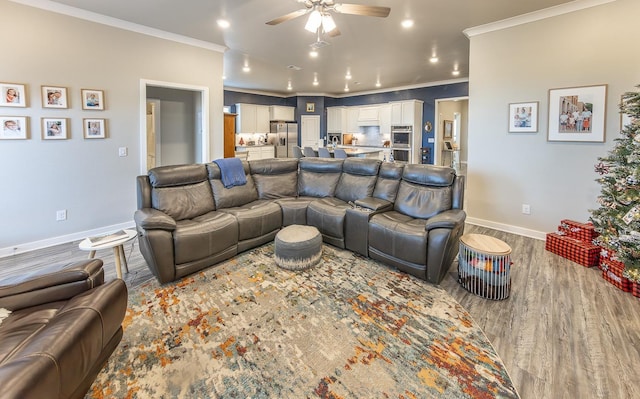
[46,0,572,95]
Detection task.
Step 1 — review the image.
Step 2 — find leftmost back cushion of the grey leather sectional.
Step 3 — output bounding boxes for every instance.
[149,164,215,220]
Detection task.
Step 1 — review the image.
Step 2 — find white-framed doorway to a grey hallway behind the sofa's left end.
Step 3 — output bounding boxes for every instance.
[140,80,210,174]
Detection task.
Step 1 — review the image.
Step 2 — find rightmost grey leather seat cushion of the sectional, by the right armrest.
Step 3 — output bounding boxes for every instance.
[369,211,427,265]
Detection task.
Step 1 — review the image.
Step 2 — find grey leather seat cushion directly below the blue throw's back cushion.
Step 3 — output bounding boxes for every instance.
[220,200,282,241]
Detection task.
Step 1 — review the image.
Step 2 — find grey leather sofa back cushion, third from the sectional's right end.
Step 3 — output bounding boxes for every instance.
[335,158,381,202]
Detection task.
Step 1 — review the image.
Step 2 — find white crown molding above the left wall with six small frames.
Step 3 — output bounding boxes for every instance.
[9,0,227,53]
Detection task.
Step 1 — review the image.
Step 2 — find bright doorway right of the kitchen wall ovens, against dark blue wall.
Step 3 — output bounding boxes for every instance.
[433,97,469,169]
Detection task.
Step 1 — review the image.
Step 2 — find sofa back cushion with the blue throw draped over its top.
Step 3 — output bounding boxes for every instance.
[207,161,258,209]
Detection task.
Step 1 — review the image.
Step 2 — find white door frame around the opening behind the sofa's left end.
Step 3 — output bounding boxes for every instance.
[139,79,210,174]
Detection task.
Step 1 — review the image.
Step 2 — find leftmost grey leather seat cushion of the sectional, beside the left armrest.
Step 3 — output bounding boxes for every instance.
[173,211,238,265]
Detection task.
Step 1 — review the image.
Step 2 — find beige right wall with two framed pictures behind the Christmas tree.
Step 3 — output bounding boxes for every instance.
[466,0,640,237]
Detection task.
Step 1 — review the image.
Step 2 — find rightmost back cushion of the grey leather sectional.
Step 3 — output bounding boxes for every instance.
[394,165,456,219]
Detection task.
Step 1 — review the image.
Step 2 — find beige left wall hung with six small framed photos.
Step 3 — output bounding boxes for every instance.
[0,0,223,255]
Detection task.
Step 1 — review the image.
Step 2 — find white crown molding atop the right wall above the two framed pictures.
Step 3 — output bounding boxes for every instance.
[462,0,616,37]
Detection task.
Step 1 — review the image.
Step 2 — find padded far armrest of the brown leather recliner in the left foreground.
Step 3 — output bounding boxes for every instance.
[0,259,104,311]
